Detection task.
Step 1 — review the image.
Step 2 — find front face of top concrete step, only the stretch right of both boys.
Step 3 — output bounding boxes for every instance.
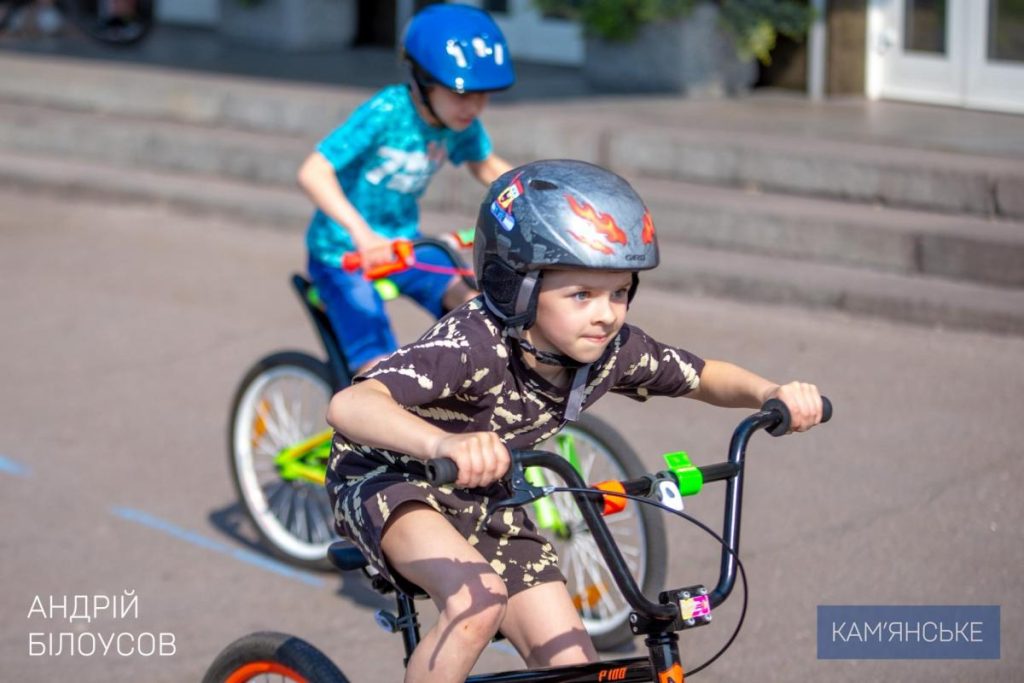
[607,118,1024,218]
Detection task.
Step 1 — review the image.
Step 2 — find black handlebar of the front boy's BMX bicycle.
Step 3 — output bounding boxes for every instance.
[426,396,833,621]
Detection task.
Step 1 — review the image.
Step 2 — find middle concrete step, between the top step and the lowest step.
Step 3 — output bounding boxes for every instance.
[0,96,1024,287]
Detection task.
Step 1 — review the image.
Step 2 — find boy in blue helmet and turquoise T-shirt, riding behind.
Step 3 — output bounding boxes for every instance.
[298,5,515,370]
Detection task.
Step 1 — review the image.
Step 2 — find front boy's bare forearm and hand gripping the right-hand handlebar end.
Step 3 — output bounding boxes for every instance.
[687,360,821,431]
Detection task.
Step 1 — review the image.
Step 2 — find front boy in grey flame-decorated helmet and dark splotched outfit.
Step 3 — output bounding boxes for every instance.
[327,161,821,681]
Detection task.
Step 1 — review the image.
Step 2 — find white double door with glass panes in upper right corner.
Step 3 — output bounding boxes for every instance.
[867,0,1024,112]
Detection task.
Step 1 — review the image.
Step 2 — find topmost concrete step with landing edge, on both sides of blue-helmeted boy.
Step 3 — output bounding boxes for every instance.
[0,54,1024,218]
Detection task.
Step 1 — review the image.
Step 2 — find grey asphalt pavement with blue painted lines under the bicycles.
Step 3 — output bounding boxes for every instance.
[0,188,1024,683]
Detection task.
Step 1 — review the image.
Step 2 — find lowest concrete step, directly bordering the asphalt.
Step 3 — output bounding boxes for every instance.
[0,153,1024,335]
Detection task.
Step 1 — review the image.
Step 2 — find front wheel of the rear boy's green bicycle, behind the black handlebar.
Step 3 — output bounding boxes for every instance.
[534,415,668,650]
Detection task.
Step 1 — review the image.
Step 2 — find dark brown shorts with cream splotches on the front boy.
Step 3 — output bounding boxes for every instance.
[327,454,565,596]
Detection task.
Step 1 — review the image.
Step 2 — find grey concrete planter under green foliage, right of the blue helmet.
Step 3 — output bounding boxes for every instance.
[583,4,758,97]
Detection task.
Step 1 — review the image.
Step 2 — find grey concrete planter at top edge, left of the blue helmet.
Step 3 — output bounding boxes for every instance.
[219,0,357,51]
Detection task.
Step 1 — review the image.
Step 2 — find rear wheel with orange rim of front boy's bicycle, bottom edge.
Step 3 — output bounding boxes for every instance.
[203,631,348,683]
